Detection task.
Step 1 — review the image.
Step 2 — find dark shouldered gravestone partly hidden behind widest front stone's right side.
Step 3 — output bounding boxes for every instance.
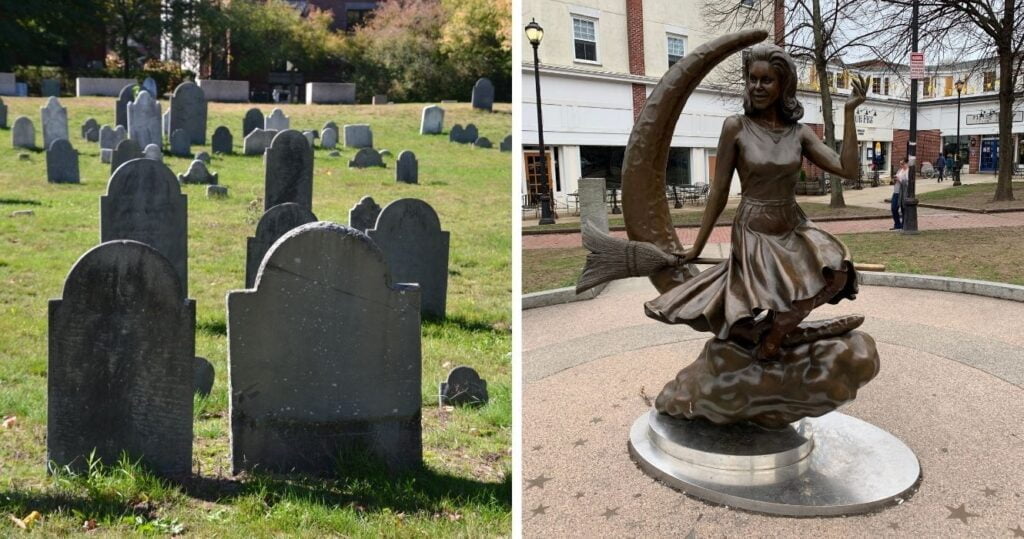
[367,199,450,318]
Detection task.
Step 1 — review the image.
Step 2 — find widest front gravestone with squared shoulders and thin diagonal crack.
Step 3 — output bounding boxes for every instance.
[227,221,423,474]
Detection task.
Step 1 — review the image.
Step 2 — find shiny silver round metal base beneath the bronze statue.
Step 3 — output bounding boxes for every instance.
[629,409,921,516]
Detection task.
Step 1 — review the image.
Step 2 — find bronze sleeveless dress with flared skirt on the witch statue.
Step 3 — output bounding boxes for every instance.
[645,115,857,339]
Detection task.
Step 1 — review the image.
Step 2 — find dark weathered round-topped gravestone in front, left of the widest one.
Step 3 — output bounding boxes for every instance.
[46,241,196,478]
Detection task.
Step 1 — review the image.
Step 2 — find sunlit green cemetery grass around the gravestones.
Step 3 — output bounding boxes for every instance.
[0,97,512,537]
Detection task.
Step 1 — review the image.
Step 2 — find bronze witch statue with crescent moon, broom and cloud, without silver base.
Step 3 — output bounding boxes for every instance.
[578,30,879,427]
